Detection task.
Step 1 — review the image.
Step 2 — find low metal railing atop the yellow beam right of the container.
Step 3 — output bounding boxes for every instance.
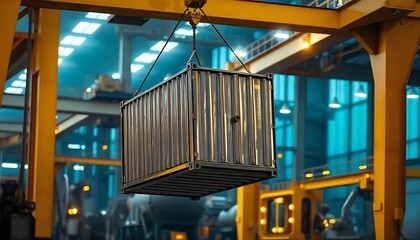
[301,156,373,181]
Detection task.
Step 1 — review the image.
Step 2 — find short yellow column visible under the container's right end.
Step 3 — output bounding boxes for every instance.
[236,183,260,240]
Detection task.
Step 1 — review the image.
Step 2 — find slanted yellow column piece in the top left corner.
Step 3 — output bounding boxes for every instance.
[0,0,20,106]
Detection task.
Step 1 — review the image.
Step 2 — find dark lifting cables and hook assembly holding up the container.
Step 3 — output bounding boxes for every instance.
[134,2,251,96]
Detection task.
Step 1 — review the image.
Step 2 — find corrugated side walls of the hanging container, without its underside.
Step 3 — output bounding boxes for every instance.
[121,66,275,183]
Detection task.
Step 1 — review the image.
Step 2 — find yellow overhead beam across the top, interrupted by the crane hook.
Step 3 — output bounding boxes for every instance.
[22,0,415,33]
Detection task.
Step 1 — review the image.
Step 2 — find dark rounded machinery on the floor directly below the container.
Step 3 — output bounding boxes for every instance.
[123,195,205,240]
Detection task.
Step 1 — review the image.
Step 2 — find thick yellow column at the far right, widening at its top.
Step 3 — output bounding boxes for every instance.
[370,20,420,240]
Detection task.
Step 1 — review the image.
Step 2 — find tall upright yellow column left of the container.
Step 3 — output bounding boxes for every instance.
[28,9,60,238]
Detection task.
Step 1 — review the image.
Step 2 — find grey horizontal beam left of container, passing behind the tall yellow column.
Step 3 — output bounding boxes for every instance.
[2,94,120,116]
